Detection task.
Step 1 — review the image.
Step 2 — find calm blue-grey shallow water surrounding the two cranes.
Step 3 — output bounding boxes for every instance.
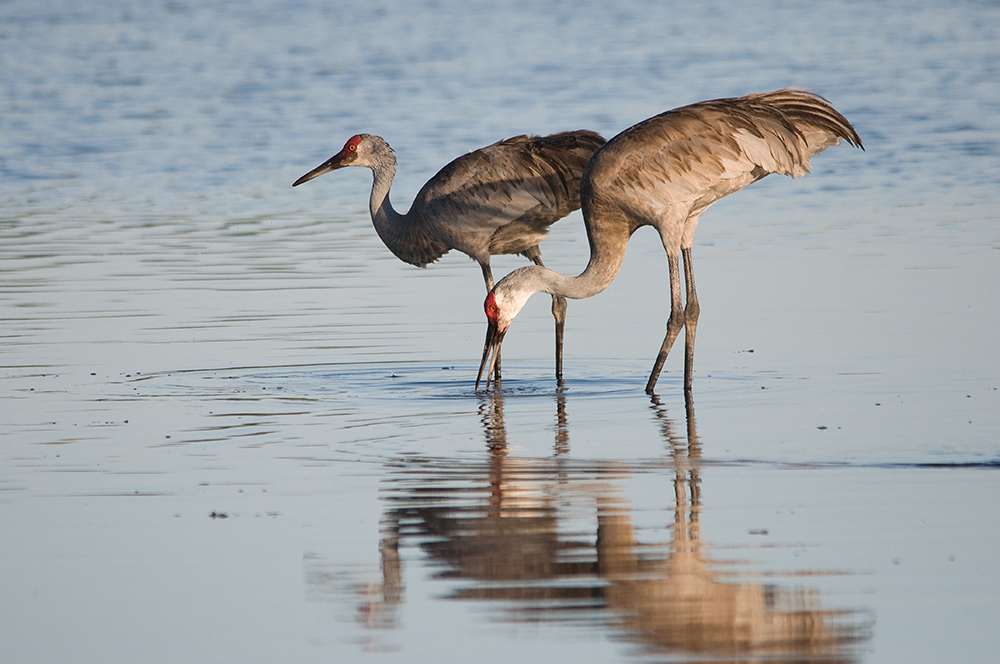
[0,0,1000,662]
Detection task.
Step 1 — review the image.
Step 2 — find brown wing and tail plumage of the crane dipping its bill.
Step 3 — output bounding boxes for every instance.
[587,89,862,224]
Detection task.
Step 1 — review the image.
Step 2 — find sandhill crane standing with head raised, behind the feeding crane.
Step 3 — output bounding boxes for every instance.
[292,130,605,381]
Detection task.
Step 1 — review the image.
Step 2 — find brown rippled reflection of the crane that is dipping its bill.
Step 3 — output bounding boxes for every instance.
[597,395,869,662]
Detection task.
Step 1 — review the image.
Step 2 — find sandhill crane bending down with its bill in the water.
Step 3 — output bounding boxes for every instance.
[476,89,864,394]
